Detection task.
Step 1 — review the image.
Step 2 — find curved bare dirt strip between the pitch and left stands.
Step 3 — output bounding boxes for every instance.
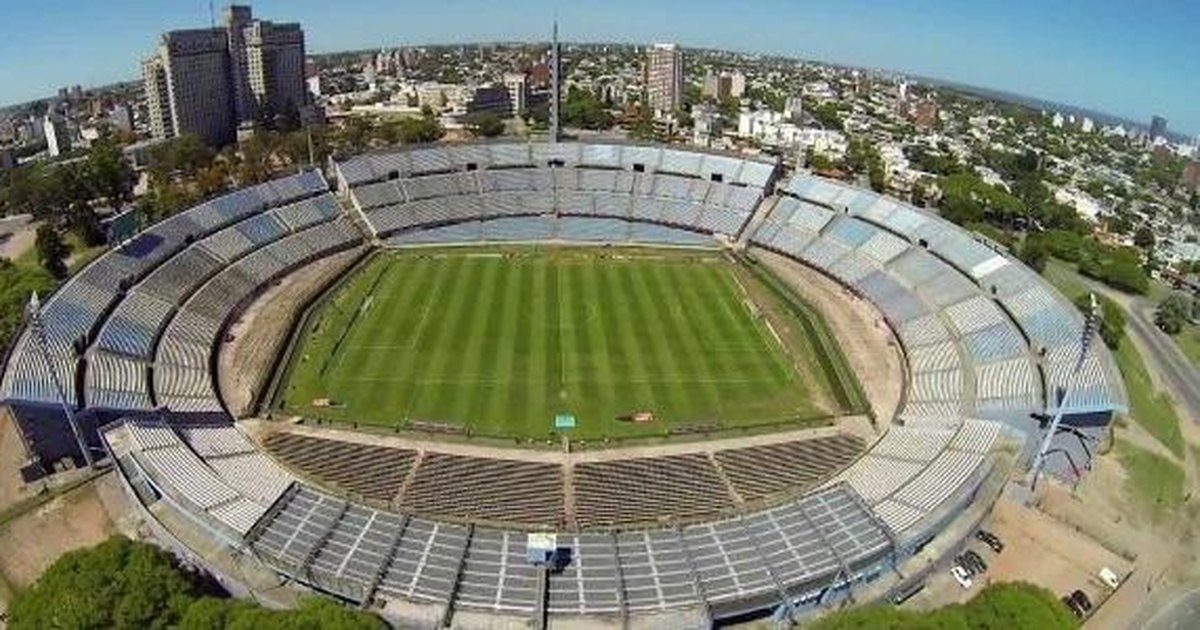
[217,250,360,418]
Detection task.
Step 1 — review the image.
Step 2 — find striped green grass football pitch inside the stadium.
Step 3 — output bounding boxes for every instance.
[276,248,846,439]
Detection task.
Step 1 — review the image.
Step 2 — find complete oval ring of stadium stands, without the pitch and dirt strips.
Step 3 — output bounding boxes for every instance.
[0,143,1126,622]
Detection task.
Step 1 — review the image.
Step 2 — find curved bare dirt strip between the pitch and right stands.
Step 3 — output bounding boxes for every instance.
[751,250,905,422]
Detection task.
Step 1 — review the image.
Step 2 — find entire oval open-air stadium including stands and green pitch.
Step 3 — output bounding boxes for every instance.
[0,142,1126,628]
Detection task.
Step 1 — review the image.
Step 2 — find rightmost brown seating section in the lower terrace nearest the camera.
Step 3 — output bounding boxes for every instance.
[713,434,864,500]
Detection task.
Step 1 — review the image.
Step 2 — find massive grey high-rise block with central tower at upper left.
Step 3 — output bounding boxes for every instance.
[142,5,307,146]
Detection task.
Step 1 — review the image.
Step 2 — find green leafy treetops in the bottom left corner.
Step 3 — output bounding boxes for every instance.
[8,536,384,630]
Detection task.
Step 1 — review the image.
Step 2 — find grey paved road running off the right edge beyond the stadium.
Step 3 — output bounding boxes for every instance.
[1084,278,1200,422]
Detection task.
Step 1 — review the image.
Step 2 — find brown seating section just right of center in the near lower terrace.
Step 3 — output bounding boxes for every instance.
[574,454,733,527]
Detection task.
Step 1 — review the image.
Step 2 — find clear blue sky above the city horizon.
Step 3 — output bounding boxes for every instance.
[0,0,1200,133]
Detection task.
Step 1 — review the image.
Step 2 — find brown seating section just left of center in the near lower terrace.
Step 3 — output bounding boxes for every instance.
[401,451,563,524]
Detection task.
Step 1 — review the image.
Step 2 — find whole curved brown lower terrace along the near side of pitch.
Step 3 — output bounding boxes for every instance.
[263,432,863,528]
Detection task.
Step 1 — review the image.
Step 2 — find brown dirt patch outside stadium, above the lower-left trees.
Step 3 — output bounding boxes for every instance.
[0,475,115,588]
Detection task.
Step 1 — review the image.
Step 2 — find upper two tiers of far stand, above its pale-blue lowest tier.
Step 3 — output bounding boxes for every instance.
[338,143,775,244]
